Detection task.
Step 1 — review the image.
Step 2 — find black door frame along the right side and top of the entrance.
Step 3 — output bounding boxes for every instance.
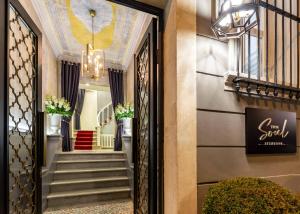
[107,0,164,214]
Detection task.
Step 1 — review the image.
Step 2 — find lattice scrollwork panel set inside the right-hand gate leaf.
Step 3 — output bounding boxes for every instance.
[135,38,150,214]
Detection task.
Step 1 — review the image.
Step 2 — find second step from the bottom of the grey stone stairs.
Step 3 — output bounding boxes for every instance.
[50,176,129,193]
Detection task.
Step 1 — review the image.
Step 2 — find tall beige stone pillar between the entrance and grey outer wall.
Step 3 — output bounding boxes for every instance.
[164,0,197,214]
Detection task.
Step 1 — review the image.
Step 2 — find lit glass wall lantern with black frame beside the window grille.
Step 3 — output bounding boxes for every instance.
[212,0,258,39]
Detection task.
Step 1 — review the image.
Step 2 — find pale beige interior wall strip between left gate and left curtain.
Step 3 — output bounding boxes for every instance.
[19,0,58,107]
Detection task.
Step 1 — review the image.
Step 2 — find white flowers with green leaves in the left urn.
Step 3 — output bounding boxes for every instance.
[45,96,72,117]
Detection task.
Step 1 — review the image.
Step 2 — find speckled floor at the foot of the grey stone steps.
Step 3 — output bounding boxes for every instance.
[44,200,133,214]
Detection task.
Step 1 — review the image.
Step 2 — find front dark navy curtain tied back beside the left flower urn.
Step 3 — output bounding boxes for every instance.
[61,61,80,152]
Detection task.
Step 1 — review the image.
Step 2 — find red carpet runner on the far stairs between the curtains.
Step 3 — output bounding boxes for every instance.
[74,131,94,150]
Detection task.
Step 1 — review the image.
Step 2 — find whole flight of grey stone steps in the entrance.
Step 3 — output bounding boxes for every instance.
[47,152,130,208]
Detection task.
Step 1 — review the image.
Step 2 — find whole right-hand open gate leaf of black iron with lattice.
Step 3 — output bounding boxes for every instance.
[133,19,158,214]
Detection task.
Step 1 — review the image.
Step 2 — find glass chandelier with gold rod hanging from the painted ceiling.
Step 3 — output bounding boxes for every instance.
[81,9,105,80]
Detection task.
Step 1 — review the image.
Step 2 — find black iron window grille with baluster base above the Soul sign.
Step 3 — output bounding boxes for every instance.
[233,0,300,101]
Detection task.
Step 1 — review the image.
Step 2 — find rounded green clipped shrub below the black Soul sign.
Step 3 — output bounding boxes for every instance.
[202,178,300,214]
